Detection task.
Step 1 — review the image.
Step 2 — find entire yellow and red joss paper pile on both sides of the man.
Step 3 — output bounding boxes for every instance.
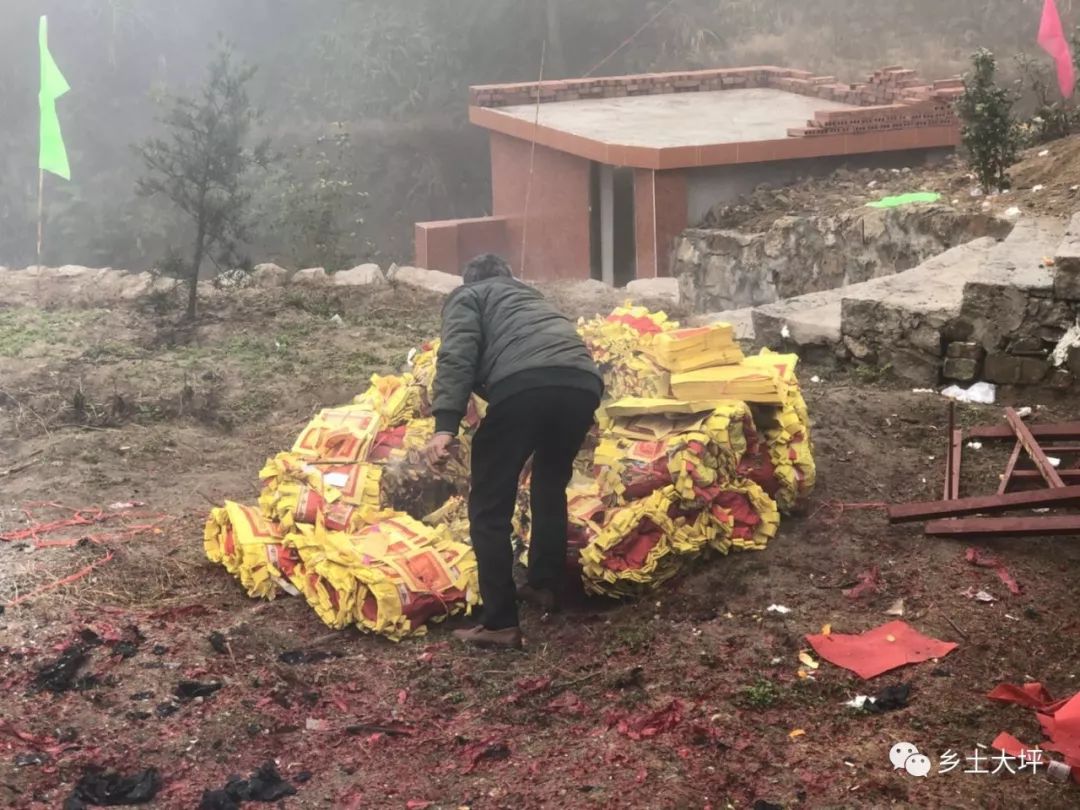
[204,307,814,639]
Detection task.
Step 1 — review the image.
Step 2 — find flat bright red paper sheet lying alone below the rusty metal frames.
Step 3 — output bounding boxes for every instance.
[807,621,957,678]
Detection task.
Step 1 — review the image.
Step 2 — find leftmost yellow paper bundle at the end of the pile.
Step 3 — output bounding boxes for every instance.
[203,501,299,599]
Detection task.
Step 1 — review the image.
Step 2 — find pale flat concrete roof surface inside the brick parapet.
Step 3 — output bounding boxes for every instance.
[491,87,859,149]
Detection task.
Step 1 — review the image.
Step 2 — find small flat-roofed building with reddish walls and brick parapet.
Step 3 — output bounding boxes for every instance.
[416,67,962,286]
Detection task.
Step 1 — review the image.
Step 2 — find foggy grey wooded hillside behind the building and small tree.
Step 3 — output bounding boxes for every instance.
[0,0,1062,270]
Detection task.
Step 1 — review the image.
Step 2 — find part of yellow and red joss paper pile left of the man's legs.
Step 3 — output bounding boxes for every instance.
[204,347,483,639]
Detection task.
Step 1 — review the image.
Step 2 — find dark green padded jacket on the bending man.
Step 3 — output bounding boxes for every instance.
[432,276,604,434]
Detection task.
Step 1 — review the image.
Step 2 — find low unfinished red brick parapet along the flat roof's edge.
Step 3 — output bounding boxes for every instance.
[470,66,963,138]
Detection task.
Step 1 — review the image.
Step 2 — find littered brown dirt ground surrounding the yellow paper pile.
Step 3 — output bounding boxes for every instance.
[0,288,1080,810]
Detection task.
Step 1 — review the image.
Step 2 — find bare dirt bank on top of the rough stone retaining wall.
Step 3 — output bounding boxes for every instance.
[701,136,1080,231]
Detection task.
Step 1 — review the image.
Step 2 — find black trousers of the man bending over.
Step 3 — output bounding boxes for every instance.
[469,387,599,630]
